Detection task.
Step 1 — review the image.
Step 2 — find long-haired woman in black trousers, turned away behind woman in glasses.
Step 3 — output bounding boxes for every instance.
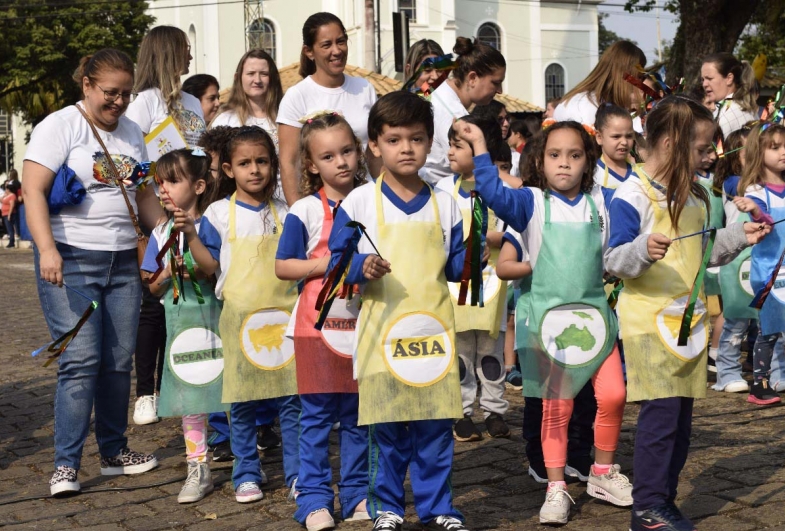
[126,26,205,425]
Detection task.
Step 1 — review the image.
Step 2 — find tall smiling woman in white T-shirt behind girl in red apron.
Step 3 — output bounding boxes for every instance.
[277,13,378,205]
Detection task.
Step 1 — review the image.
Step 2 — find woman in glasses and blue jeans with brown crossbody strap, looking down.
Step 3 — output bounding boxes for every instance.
[22,49,163,495]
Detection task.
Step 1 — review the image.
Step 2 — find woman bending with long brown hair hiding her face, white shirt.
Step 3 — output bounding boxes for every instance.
[553,41,646,133]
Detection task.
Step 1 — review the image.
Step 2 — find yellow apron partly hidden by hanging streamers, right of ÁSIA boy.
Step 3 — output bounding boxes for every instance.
[448,177,507,339]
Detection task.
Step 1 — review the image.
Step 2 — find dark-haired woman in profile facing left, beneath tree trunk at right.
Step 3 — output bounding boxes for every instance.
[701,52,758,138]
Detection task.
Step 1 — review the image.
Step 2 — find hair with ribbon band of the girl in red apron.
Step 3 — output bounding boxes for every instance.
[300,111,368,197]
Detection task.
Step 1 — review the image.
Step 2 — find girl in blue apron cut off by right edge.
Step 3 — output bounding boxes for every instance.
[733,122,785,405]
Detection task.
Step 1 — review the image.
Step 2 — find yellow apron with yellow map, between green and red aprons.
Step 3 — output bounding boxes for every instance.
[219,195,297,403]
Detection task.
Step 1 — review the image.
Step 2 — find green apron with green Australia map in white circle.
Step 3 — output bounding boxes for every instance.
[516,191,618,399]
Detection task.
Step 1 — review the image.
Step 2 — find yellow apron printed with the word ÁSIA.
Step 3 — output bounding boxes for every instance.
[354,174,463,425]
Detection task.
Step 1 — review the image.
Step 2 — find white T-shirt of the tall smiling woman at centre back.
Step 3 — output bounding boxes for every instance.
[277,75,376,148]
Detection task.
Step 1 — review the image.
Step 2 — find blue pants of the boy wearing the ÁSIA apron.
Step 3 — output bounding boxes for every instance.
[368,419,463,525]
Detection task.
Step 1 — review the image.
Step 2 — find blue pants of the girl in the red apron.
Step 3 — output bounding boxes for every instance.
[294,393,368,524]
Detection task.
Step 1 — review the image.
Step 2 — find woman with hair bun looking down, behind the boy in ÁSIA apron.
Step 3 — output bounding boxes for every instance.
[420,37,507,185]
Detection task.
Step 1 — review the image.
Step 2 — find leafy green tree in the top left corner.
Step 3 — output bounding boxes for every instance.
[0,0,155,124]
